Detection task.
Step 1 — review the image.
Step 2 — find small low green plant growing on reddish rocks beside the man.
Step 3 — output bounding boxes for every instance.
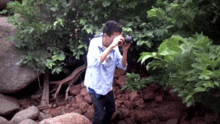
[122,73,147,91]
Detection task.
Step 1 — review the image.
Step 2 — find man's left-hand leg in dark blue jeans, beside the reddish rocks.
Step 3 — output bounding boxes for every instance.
[89,93,105,124]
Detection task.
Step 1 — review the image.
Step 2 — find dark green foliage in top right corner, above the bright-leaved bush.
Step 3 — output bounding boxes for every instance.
[147,0,220,40]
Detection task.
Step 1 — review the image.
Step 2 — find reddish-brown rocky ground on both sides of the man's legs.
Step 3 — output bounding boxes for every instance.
[17,69,219,124]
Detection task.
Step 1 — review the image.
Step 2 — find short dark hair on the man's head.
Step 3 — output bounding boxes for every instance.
[103,20,122,37]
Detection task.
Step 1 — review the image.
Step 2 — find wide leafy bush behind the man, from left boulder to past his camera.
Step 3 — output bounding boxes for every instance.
[5,0,171,73]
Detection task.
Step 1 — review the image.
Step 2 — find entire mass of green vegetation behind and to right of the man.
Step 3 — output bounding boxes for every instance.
[3,0,220,113]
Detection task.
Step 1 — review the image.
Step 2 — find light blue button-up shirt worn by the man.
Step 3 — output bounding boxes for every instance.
[84,37,127,95]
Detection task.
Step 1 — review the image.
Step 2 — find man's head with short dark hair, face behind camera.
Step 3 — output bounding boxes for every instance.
[103,20,122,47]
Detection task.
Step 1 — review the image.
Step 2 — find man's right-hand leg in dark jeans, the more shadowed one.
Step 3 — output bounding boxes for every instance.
[104,91,115,124]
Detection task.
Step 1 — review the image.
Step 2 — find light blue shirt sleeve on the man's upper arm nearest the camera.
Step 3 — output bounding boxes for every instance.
[87,40,101,67]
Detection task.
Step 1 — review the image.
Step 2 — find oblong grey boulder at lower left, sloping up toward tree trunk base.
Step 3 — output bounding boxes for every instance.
[10,106,40,124]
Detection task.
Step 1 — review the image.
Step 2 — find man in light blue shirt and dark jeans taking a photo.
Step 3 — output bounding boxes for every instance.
[85,20,130,124]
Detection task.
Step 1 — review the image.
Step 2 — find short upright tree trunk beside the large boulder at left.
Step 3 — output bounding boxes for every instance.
[40,68,50,106]
